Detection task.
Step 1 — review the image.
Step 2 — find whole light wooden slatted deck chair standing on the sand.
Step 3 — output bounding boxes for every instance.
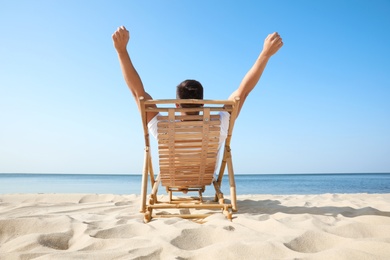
[140,97,240,222]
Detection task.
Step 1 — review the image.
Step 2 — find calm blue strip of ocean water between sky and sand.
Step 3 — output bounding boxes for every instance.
[0,173,390,196]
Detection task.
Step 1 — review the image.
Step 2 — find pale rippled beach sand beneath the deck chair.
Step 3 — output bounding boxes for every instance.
[0,194,390,260]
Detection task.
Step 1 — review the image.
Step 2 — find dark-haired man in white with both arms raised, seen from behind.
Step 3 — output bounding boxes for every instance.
[112,26,283,136]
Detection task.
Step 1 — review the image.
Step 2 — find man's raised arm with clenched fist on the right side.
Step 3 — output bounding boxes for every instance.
[229,32,283,117]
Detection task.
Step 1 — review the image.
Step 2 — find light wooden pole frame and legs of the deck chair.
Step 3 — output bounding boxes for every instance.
[139,97,240,223]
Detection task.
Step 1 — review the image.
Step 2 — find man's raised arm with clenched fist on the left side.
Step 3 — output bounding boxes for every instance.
[112,26,155,122]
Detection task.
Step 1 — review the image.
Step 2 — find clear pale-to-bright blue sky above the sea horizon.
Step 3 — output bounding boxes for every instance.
[0,0,390,173]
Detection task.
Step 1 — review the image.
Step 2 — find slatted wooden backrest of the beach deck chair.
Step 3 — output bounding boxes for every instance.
[140,99,238,187]
